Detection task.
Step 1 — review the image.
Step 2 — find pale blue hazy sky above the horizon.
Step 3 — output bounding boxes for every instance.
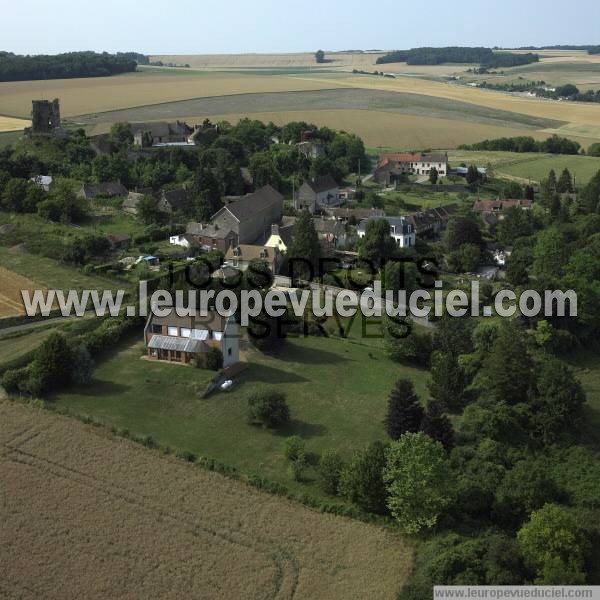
[0,0,600,54]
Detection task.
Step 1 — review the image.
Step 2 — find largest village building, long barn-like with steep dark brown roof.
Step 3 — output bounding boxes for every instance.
[211,185,283,245]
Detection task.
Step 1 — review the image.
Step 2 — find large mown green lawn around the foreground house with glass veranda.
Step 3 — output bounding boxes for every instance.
[53,337,427,491]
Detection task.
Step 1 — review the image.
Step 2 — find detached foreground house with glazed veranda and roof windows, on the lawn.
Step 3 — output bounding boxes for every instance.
[144,308,240,367]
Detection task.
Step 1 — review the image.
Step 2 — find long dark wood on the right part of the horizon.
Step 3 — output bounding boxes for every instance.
[377,46,539,68]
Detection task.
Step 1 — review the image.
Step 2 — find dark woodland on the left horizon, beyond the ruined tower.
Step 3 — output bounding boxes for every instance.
[0,51,149,81]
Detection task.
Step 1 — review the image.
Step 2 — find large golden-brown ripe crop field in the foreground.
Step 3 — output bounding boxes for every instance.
[0,402,412,599]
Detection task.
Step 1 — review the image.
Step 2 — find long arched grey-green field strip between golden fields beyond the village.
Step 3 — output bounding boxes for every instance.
[77,87,564,129]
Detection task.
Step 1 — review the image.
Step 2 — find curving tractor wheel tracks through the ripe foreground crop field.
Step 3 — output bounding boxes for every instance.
[0,427,300,600]
